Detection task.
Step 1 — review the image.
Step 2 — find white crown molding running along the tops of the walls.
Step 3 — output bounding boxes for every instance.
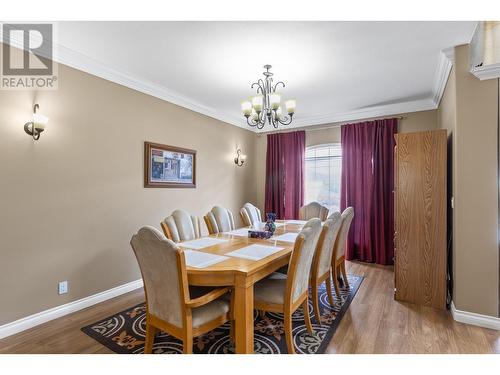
[2,27,458,133]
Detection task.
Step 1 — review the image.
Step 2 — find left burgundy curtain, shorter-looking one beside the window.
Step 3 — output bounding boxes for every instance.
[265,130,306,219]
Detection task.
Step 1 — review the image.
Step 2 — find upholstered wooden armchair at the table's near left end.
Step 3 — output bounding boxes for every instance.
[130,226,230,353]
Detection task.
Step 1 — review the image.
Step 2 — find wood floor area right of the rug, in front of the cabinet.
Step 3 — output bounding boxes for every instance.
[326,262,500,354]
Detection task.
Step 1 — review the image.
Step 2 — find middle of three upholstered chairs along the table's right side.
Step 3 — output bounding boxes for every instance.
[310,211,342,325]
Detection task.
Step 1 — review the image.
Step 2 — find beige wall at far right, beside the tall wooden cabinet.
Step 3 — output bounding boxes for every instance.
[438,45,499,316]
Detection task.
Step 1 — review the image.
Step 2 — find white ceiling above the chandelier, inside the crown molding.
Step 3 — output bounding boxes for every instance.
[51,22,476,130]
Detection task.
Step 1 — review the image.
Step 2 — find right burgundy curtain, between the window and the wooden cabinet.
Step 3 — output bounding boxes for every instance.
[340,119,398,264]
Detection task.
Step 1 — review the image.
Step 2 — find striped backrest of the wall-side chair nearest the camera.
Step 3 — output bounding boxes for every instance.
[161,210,201,242]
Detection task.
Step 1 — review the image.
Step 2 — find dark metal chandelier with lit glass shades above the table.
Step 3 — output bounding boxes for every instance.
[241,65,295,129]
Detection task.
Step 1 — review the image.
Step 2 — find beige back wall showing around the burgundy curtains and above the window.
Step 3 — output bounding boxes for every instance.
[255,111,438,209]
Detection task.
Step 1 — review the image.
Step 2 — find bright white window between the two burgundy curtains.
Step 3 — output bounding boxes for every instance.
[305,143,342,212]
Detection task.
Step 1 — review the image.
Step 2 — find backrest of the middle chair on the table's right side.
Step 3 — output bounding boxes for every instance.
[312,211,342,277]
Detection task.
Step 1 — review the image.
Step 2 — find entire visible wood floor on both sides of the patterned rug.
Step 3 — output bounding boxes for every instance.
[0,262,500,353]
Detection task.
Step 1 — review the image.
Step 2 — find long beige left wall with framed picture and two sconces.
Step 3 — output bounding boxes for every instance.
[0,61,255,325]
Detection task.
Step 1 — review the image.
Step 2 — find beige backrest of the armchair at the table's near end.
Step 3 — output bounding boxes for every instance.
[130,226,189,328]
